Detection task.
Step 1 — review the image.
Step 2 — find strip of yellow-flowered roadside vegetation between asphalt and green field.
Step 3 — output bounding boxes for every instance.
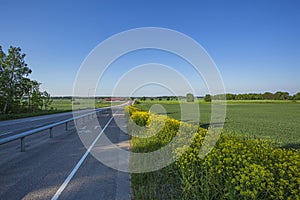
[127,104,300,200]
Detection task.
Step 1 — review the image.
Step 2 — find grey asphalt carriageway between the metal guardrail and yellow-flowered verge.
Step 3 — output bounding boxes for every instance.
[0,108,130,200]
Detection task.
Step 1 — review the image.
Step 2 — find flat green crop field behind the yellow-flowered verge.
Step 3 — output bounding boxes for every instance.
[136,101,300,148]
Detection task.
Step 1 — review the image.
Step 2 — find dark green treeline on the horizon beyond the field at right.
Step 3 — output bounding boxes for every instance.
[211,91,300,100]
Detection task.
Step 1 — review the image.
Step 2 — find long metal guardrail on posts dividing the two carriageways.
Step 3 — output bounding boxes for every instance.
[0,102,129,152]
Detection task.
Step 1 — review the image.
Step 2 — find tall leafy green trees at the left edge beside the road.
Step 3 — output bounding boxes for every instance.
[0,46,52,114]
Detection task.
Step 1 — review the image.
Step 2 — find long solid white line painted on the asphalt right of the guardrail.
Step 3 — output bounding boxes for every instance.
[51,113,114,200]
